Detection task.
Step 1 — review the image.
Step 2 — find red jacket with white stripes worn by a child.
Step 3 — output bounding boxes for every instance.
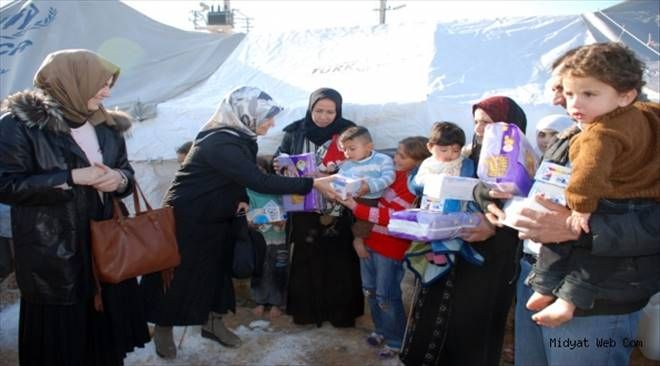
[353,171,415,260]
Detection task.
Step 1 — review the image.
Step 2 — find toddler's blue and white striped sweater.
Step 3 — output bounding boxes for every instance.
[338,151,396,199]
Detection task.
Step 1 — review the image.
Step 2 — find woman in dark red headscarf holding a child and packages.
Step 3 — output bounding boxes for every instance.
[401,96,527,365]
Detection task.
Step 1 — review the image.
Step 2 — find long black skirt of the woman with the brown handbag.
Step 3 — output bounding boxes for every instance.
[18,279,150,365]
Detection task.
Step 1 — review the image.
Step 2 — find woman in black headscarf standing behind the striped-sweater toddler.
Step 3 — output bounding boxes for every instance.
[278,88,364,327]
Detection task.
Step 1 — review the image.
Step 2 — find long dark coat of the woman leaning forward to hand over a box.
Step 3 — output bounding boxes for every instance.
[141,129,313,326]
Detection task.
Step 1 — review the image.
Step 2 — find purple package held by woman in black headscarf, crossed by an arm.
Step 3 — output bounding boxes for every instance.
[276,153,321,212]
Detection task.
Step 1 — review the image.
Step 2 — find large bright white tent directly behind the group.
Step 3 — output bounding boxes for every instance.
[128,16,594,204]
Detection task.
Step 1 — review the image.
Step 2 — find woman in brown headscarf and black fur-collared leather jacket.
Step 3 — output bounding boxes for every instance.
[0,50,149,365]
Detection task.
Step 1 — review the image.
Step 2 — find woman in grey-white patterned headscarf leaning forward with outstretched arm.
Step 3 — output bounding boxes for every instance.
[142,87,332,358]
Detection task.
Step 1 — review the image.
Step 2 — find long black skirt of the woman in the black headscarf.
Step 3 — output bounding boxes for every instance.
[287,213,364,327]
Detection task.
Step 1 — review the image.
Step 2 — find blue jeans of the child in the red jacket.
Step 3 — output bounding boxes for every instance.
[360,248,406,349]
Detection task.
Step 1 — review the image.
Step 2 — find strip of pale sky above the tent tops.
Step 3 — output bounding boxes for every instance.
[123,0,621,31]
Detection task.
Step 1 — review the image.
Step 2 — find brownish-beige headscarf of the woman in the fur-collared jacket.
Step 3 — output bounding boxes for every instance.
[34,49,119,124]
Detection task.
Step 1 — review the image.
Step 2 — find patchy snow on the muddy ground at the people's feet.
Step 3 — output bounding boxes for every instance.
[0,282,410,366]
